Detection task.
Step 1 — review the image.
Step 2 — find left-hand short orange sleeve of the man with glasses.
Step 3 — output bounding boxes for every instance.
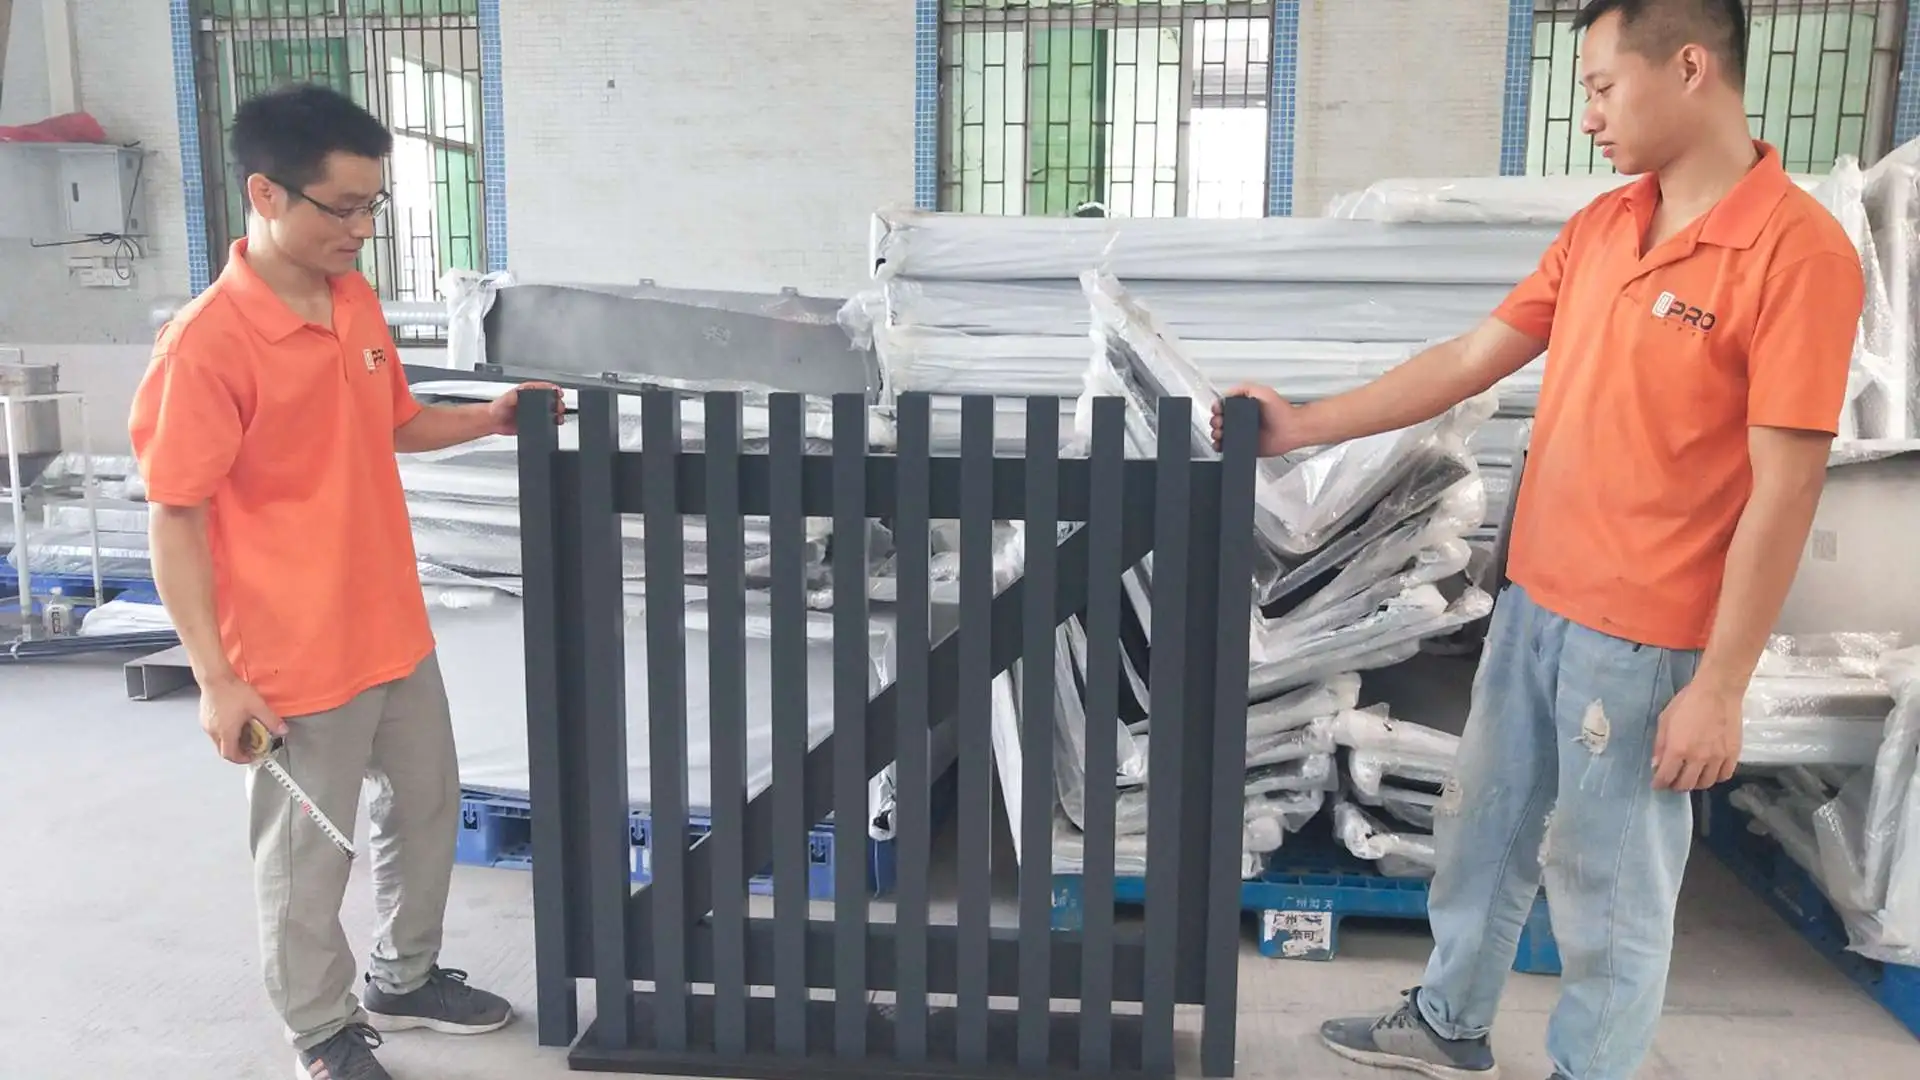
[127,342,242,505]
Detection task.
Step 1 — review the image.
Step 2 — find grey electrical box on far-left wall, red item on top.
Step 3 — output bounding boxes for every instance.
[0,142,146,242]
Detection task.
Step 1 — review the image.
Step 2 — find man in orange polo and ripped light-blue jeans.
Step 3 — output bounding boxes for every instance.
[1213,0,1864,1080]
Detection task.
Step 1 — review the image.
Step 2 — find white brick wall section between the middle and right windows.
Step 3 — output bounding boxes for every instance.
[1294,0,1507,215]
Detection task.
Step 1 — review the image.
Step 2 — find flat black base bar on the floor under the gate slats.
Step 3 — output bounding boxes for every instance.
[566,992,1173,1080]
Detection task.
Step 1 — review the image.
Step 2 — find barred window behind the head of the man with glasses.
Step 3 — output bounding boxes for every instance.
[194,0,486,332]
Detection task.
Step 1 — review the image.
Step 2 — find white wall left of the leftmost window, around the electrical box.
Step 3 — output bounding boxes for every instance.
[0,0,188,343]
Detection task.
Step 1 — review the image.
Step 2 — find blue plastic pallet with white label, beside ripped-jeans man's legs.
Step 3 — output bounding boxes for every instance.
[1052,822,1561,974]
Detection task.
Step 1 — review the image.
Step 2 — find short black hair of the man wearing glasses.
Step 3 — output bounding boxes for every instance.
[232,83,394,188]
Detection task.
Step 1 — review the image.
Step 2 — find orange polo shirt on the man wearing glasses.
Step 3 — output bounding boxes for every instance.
[129,240,434,717]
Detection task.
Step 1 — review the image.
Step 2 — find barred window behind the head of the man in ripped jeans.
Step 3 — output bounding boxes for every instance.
[1526,0,1907,175]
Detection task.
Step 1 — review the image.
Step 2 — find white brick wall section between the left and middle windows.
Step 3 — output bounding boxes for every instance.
[501,0,914,294]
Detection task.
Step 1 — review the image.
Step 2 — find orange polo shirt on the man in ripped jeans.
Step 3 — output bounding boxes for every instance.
[1496,144,1864,650]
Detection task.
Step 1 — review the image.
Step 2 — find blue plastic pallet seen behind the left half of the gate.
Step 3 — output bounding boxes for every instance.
[453,790,895,899]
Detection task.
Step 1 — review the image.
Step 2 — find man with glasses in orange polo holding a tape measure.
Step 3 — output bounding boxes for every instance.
[131,86,556,1080]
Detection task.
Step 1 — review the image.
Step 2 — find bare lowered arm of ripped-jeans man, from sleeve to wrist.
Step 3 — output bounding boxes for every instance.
[1695,427,1834,684]
